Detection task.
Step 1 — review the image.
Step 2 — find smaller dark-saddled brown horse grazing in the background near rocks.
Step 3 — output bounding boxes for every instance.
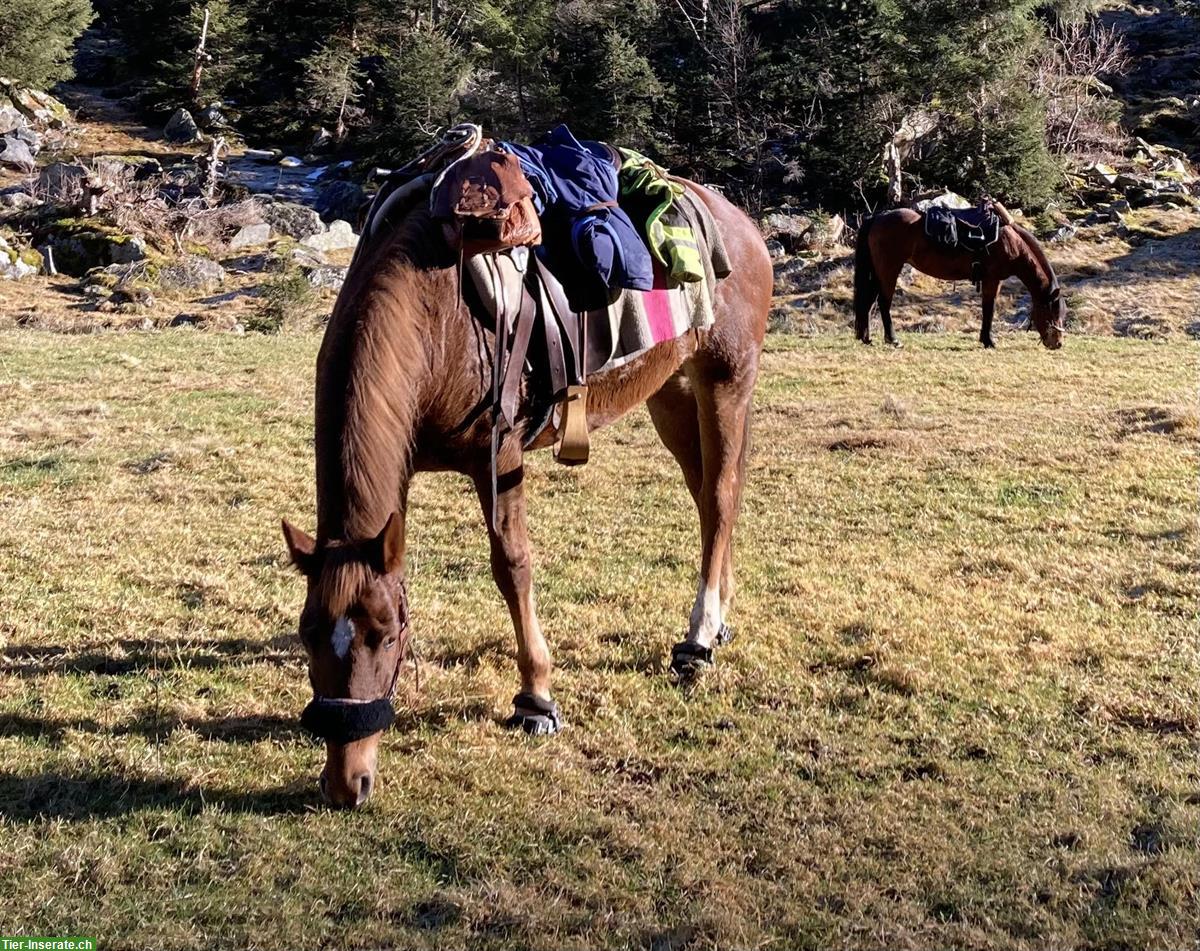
[854,208,1067,349]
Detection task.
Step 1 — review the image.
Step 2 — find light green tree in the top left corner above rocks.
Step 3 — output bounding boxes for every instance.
[0,0,95,89]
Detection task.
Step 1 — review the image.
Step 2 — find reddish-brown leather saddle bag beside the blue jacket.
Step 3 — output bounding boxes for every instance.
[432,149,541,257]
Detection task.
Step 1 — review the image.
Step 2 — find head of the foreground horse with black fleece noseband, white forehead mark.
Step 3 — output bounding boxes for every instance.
[283,515,408,808]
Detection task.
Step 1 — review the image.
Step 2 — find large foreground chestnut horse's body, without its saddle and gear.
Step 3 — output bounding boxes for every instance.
[283,186,773,807]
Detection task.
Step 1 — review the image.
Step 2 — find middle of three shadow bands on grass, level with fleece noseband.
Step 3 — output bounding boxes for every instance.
[0,711,310,743]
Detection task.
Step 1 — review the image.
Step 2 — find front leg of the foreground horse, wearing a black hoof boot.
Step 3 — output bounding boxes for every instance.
[474,449,562,736]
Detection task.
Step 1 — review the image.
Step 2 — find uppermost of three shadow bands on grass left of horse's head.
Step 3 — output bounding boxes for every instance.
[0,633,302,677]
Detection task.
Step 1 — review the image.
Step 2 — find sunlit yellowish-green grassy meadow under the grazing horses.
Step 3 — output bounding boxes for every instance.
[0,331,1200,951]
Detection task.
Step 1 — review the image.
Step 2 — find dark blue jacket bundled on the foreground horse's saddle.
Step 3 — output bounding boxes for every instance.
[502,125,654,311]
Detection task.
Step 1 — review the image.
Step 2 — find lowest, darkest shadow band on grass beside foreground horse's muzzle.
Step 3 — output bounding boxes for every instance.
[0,772,318,821]
